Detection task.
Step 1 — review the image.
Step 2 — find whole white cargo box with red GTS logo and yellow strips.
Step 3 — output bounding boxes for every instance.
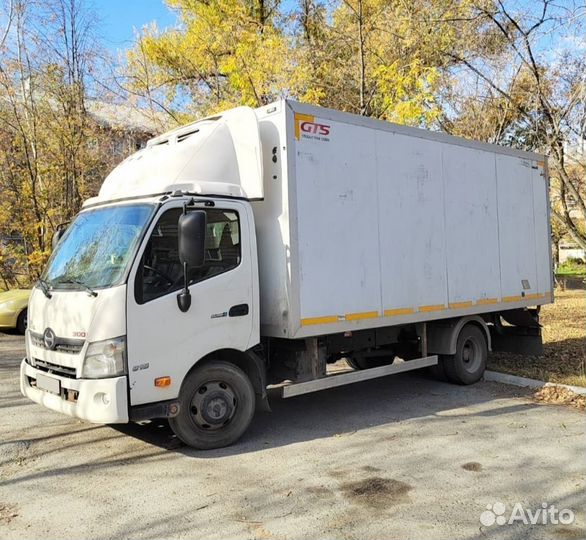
[253,101,553,338]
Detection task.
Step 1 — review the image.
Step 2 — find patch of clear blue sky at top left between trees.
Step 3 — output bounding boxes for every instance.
[90,0,176,56]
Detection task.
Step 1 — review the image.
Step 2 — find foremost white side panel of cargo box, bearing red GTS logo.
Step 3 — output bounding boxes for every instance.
[295,108,381,324]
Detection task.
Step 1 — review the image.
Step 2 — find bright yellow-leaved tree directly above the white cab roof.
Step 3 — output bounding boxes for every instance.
[125,0,293,120]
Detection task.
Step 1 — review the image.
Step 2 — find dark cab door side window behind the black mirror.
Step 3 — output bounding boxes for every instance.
[135,208,242,304]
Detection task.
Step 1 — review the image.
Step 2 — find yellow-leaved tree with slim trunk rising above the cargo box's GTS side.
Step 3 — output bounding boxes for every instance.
[298,0,460,125]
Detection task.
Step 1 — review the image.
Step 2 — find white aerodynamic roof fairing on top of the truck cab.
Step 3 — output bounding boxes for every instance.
[92,107,263,203]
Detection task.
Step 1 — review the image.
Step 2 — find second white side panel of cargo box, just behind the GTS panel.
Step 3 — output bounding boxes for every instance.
[376,131,448,318]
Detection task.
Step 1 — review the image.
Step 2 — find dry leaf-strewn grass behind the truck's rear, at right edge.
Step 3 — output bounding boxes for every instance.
[488,291,586,386]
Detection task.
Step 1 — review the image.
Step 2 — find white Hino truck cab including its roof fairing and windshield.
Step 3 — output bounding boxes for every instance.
[21,104,266,446]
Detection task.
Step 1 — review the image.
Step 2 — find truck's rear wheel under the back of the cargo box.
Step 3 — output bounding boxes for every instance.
[440,324,488,384]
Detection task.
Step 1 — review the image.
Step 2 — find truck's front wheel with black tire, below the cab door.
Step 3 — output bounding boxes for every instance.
[169,360,255,450]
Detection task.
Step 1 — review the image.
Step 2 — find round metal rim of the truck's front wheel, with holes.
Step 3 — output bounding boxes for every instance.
[189,381,238,431]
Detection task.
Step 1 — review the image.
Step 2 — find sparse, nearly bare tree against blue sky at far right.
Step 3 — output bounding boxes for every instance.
[442,0,586,249]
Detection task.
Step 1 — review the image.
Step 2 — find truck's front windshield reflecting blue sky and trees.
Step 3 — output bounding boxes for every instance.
[42,204,154,289]
